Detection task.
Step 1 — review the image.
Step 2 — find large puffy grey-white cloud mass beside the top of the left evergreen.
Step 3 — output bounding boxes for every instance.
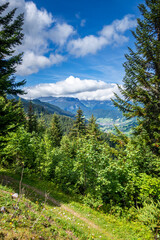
[2,0,74,76]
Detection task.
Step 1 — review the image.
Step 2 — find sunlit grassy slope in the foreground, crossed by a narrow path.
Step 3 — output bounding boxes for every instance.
[0,171,153,240]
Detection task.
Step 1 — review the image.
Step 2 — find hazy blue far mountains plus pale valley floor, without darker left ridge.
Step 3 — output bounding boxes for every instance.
[34,97,136,134]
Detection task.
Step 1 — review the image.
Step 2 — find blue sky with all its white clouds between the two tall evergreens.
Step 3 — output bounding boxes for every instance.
[1,0,144,100]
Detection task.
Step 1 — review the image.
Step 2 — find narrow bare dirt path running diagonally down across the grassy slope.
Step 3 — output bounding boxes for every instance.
[2,176,117,240]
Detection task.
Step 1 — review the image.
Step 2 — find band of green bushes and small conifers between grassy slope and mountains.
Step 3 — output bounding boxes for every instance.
[0,97,160,229]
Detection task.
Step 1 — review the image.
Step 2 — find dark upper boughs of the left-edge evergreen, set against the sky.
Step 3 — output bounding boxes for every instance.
[0,3,25,96]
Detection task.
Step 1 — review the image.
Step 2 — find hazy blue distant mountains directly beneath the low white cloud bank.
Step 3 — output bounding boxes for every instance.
[37,97,123,120]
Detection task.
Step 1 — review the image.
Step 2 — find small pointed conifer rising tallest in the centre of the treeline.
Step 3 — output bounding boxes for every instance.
[70,108,86,137]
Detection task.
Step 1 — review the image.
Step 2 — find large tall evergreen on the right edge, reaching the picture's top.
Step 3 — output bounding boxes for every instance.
[113,0,160,153]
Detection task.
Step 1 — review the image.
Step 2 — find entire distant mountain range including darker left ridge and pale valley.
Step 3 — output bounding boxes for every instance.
[8,95,136,133]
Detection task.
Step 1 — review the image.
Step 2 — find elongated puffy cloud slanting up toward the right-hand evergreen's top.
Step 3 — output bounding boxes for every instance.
[68,15,136,57]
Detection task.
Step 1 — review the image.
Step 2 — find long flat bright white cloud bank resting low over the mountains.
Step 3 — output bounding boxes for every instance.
[22,76,118,100]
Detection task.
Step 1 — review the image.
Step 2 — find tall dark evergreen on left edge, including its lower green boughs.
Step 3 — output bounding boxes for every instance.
[0,3,25,158]
